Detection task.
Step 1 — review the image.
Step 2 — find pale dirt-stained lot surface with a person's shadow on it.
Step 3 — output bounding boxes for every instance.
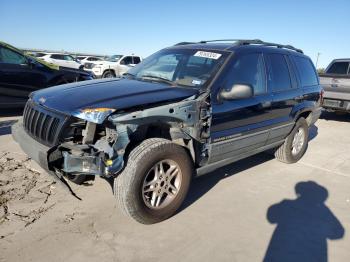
[0,113,350,262]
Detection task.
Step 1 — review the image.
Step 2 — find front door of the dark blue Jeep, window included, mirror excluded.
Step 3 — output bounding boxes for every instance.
[209,53,273,163]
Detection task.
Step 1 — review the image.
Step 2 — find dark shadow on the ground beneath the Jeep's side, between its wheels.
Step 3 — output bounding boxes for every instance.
[179,153,274,212]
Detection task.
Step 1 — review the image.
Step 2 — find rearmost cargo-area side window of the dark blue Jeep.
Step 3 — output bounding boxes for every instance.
[293,56,318,86]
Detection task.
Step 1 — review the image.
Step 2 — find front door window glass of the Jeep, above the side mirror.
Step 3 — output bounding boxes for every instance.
[225,54,266,95]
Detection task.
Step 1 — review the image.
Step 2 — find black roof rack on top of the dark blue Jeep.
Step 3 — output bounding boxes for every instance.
[176,39,304,54]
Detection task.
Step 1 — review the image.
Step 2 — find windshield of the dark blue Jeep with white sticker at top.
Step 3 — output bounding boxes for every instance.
[127,49,224,87]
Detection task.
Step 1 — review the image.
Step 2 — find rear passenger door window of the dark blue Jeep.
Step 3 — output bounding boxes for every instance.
[266,54,292,91]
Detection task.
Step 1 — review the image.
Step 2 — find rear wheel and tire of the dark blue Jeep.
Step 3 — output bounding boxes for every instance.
[275,117,309,164]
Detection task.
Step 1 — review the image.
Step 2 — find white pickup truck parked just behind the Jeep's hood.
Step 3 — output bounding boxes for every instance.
[84,55,142,78]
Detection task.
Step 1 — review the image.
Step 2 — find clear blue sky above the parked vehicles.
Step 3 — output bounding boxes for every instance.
[0,0,350,67]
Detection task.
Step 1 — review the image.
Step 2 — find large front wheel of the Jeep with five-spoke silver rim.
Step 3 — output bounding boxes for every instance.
[114,138,193,224]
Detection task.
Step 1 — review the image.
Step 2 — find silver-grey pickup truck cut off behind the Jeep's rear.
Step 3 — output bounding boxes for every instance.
[320,58,350,112]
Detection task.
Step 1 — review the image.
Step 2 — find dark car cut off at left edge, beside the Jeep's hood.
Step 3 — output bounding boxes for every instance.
[0,42,93,108]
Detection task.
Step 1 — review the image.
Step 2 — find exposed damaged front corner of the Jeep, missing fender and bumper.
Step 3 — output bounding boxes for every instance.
[57,95,210,177]
